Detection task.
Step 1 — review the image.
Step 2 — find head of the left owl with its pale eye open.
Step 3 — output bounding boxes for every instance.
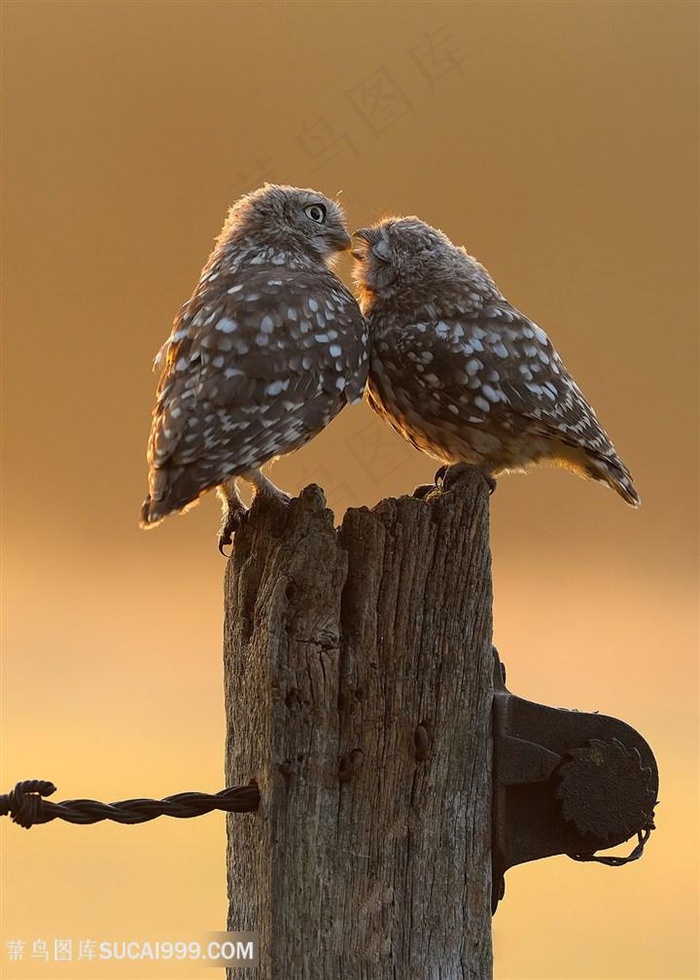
[217,184,351,262]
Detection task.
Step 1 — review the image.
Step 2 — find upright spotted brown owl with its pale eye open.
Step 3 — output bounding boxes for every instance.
[141,184,368,550]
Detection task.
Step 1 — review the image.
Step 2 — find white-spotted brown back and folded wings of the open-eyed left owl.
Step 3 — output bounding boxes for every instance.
[148,266,367,484]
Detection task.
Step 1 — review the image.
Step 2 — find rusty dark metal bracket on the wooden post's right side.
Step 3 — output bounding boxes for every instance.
[491,647,659,912]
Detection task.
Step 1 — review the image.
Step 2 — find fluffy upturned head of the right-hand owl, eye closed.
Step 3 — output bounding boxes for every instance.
[352,216,495,308]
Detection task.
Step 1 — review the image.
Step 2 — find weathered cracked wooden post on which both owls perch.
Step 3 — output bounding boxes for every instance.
[225,477,493,980]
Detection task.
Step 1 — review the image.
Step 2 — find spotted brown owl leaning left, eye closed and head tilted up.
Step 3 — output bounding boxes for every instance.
[352,217,640,507]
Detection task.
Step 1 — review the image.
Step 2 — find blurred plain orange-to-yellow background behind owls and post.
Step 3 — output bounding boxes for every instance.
[0,0,700,980]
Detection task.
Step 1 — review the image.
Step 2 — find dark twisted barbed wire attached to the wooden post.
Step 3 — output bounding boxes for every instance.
[0,779,260,830]
